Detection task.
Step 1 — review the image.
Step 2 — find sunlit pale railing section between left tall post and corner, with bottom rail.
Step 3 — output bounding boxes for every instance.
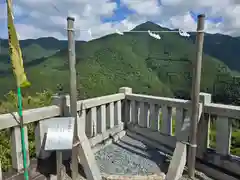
[75,88,125,151]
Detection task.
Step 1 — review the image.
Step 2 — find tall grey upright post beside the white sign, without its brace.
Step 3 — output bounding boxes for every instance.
[67,17,78,180]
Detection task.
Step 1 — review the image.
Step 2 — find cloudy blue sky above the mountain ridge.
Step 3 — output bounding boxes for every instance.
[0,0,236,39]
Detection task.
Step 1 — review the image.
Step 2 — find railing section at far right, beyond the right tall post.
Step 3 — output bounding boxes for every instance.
[200,103,240,176]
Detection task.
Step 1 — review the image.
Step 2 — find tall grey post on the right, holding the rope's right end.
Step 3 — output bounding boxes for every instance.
[188,14,205,178]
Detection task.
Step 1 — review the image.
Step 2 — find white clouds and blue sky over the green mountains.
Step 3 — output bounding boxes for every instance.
[0,0,240,40]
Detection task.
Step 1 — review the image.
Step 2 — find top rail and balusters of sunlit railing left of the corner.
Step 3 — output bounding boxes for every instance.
[74,93,125,139]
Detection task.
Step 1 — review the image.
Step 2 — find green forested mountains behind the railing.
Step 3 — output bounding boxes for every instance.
[0,22,240,105]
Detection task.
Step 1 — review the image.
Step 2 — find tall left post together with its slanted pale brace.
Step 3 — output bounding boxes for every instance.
[67,17,102,180]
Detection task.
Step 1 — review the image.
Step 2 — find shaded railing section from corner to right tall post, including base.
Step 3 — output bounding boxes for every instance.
[125,93,191,154]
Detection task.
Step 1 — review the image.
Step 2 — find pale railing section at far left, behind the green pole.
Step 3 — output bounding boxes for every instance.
[0,105,61,179]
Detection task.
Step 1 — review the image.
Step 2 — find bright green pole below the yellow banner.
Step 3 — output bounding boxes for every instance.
[17,87,29,180]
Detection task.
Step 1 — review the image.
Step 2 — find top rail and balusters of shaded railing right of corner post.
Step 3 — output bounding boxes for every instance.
[126,94,190,136]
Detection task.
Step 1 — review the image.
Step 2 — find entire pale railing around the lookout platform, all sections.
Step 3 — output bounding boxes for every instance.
[0,87,240,180]
